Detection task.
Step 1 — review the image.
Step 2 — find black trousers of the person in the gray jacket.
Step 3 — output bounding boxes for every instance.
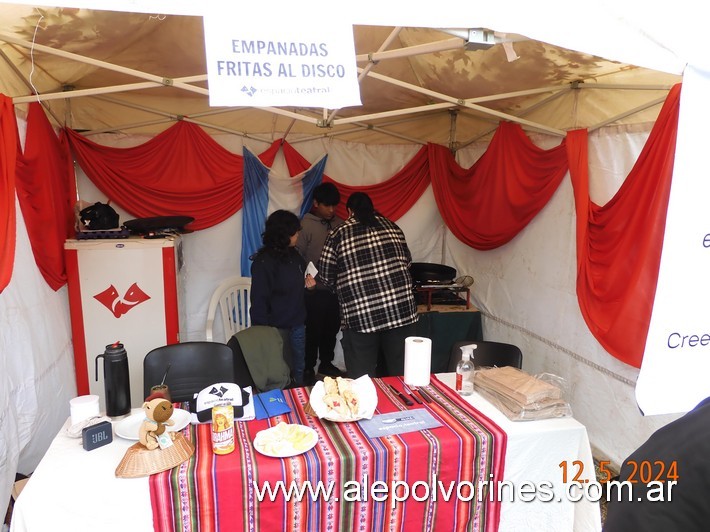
[306,289,340,371]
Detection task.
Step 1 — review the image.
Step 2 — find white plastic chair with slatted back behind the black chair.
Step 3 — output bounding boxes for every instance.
[205,277,251,343]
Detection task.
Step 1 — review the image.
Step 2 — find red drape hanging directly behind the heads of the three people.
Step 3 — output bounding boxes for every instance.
[283,142,430,221]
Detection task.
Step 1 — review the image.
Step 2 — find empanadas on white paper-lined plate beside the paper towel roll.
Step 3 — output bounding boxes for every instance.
[310,375,377,422]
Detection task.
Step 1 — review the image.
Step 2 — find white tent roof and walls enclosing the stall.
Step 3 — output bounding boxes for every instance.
[5,0,710,516]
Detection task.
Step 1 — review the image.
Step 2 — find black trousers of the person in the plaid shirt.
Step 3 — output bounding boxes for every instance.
[343,323,416,379]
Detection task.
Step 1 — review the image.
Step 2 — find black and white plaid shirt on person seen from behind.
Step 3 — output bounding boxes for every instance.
[318,215,418,333]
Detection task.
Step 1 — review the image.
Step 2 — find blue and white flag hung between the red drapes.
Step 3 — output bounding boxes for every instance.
[241,148,328,277]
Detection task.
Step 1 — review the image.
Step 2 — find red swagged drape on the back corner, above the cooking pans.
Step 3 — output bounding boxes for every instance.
[429,122,567,250]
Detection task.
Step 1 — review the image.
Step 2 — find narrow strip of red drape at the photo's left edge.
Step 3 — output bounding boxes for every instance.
[0,94,18,292]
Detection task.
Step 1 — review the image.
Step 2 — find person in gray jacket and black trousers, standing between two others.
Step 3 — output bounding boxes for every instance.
[296,182,343,385]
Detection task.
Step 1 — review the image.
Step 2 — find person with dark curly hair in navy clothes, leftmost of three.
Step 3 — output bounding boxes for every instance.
[250,210,316,386]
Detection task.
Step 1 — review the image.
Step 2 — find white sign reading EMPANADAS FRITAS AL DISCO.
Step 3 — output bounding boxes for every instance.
[204,2,361,109]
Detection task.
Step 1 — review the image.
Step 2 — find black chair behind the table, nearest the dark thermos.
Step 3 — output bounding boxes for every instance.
[143,342,236,402]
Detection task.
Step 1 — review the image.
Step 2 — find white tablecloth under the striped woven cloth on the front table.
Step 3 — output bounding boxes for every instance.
[11,374,601,532]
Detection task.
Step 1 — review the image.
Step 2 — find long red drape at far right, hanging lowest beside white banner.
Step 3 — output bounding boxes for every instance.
[567,84,681,367]
